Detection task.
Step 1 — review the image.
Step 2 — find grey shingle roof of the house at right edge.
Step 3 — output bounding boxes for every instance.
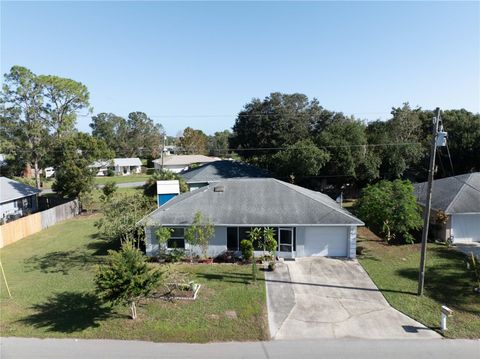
[414,172,480,214]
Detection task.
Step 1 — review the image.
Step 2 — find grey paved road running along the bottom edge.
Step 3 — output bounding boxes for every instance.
[0,338,480,359]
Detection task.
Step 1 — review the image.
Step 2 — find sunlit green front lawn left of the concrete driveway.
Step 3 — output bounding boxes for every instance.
[0,216,268,342]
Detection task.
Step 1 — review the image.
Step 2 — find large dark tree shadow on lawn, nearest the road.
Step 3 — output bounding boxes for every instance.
[19,292,118,333]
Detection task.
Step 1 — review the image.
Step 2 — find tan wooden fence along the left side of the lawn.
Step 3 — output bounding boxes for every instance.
[0,200,80,248]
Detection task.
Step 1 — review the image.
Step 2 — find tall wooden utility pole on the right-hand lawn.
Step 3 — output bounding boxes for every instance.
[417,107,440,296]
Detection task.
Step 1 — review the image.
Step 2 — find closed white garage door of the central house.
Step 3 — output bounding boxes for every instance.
[303,227,348,257]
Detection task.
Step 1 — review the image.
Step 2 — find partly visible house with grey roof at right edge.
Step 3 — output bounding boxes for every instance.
[414,172,480,243]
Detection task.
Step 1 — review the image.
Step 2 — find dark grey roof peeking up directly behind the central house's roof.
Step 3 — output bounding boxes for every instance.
[181,160,272,183]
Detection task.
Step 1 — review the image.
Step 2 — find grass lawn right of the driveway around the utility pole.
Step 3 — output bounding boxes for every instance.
[358,228,480,338]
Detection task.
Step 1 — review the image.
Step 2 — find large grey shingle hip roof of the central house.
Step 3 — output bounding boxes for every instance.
[141,178,363,226]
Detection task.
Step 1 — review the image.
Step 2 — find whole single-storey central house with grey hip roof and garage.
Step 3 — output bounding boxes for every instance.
[141,178,364,258]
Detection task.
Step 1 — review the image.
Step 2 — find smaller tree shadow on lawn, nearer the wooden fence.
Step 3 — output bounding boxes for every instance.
[24,250,102,275]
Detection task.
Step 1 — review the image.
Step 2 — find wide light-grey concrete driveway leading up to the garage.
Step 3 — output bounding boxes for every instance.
[266,257,441,339]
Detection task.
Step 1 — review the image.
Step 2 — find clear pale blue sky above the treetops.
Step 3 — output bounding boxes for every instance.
[1,1,480,135]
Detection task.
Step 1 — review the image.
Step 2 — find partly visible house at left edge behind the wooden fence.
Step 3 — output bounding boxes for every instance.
[0,177,41,223]
